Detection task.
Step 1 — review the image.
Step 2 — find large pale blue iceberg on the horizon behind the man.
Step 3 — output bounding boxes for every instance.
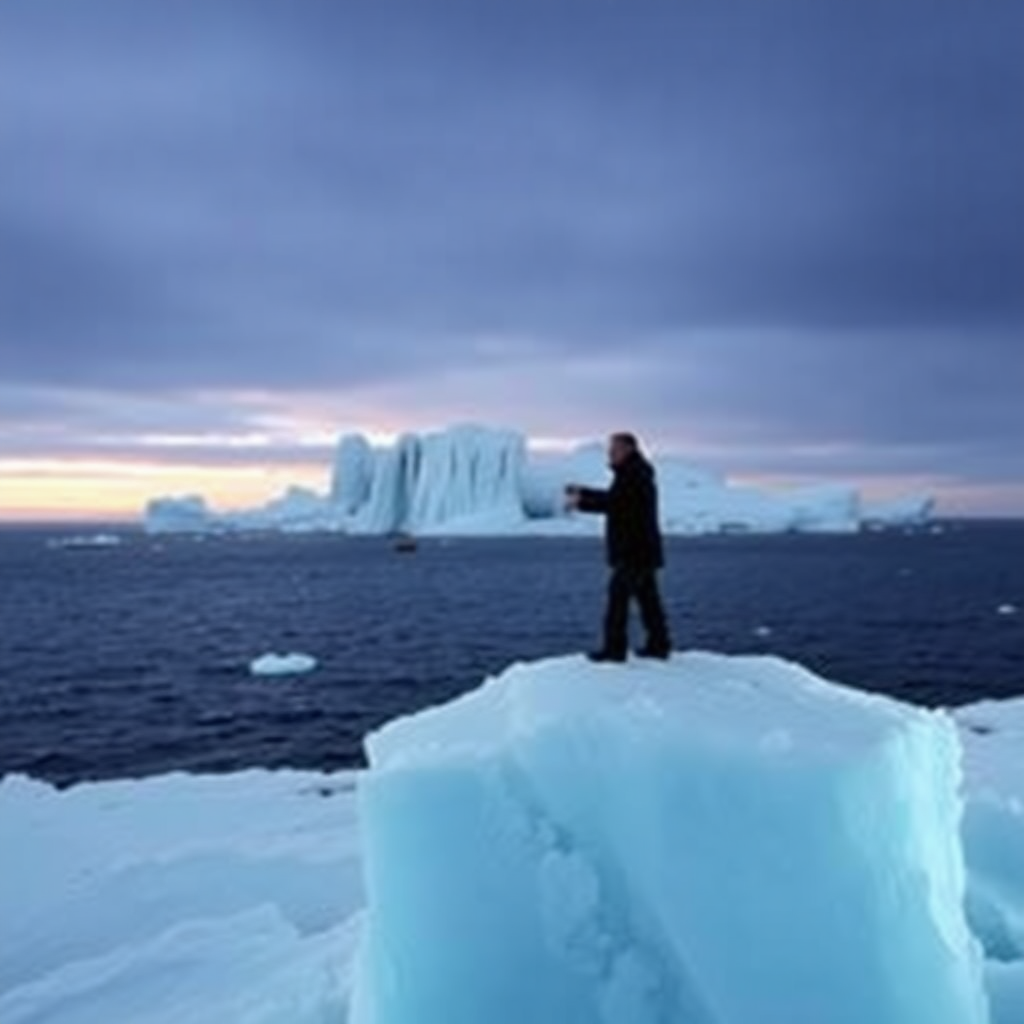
[145,426,934,537]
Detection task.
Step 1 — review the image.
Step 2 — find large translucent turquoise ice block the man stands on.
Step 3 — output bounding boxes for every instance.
[353,653,989,1024]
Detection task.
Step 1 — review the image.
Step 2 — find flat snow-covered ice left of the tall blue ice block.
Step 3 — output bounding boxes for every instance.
[0,771,362,1024]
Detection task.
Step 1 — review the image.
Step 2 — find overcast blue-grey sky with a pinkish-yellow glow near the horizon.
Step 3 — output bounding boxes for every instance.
[0,0,1024,514]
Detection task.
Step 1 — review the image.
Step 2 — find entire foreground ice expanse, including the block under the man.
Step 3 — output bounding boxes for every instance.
[6,654,1024,1024]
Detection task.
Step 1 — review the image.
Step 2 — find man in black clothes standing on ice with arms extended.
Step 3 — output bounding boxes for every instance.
[565,433,672,662]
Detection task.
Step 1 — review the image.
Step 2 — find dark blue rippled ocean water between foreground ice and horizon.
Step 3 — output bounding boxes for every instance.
[0,524,1024,783]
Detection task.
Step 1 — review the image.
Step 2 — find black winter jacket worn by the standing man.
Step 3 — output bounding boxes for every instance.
[579,452,665,569]
